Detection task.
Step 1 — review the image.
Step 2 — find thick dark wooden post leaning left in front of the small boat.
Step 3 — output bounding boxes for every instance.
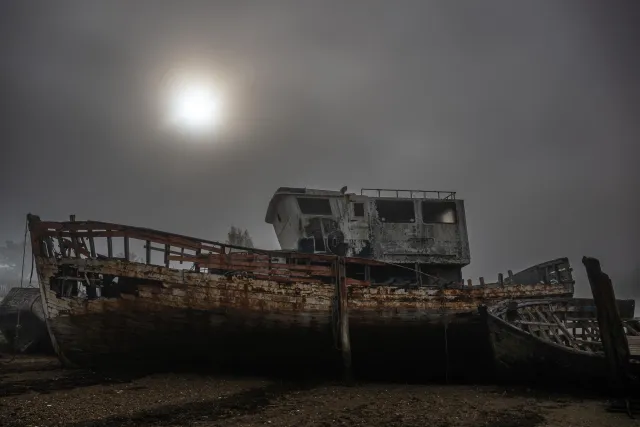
[582,257,630,397]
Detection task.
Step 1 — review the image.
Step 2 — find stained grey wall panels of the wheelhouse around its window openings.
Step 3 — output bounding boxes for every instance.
[265,188,470,269]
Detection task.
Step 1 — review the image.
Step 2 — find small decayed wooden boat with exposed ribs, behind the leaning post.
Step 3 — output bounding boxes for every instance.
[480,299,640,384]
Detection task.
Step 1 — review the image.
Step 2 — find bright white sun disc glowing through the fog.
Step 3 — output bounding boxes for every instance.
[170,82,222,132]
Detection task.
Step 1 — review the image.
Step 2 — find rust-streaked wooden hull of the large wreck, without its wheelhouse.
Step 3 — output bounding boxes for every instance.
[30,214,573,378]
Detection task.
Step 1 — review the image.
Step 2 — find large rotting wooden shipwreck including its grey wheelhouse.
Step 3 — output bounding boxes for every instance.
[28,188,574,378]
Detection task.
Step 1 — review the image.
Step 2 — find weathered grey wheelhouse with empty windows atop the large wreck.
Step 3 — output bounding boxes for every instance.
[265,187,470,285]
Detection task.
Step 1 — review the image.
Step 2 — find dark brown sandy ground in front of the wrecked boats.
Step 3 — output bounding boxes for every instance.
[0,356,640,427]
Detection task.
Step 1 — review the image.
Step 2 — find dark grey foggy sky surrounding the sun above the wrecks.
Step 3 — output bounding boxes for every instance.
[0,0,640,297]
